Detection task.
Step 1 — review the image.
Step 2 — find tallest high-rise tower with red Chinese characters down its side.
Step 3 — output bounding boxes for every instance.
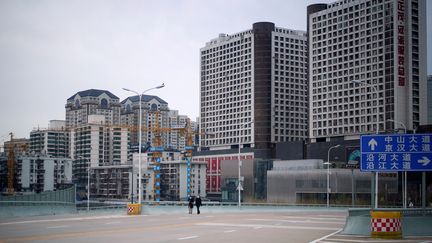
[308,0,427,142]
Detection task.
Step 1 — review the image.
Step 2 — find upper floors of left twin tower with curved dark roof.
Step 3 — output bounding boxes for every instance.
[65,89,120,128]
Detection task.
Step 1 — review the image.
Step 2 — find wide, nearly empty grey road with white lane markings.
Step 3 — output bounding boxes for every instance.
[0,210,432,243]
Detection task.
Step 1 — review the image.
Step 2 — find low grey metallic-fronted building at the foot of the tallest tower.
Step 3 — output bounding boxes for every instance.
[267,166,400,207]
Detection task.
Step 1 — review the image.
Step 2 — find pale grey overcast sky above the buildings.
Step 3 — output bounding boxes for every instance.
[0,0,432,140]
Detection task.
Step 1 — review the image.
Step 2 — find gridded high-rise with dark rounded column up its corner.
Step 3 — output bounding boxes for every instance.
[200,22,308,157]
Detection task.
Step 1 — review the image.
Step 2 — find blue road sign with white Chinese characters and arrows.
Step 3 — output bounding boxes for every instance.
[360,134,432,172]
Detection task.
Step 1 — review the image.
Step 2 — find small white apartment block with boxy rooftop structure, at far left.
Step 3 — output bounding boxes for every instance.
[29,121,70,158]
